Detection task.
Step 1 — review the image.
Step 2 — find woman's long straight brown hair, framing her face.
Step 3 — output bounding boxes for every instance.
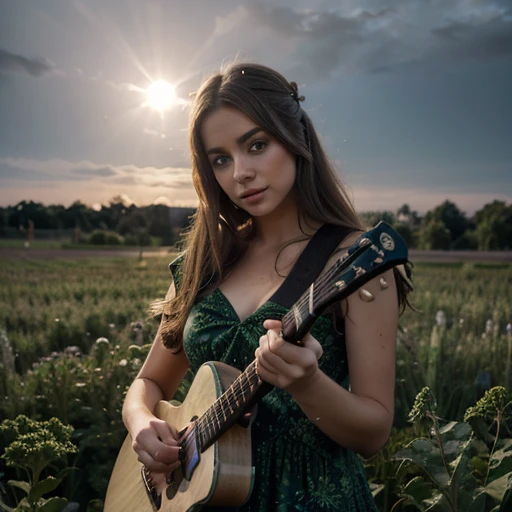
[161,63,370,351]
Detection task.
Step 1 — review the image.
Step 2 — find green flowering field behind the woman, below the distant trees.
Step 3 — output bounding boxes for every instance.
[0,254,512,510]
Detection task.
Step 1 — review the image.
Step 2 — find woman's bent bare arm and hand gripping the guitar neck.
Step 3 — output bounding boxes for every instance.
[256,270,398,458]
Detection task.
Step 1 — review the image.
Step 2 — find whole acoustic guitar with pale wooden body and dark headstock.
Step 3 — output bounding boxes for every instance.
[104,222,409,512]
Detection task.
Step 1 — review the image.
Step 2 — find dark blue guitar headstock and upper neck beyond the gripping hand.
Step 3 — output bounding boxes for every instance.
[283,221,409,341]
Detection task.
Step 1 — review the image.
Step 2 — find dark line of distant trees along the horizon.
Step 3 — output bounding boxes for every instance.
[0,196,512,250]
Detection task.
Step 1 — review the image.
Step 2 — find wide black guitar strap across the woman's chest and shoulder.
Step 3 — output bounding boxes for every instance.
[269,224,353,309]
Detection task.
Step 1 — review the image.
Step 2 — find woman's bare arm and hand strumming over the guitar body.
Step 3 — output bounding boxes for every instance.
[123,285,190,473]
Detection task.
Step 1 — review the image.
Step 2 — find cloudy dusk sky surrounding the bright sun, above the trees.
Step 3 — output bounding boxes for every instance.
[0,0,512,215]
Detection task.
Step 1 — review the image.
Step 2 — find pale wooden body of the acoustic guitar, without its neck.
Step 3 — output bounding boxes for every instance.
[104,362,253,512]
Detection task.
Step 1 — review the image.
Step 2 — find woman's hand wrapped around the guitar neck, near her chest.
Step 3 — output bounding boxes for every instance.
[254,320,323,395]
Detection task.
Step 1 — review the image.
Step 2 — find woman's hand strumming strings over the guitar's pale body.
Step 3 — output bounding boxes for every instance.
[132,415,180,475]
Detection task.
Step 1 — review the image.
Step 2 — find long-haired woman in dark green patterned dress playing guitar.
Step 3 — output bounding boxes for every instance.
[123,64,405,512]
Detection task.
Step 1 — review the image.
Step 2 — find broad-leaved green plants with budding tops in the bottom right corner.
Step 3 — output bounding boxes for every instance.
[392,387,512,512]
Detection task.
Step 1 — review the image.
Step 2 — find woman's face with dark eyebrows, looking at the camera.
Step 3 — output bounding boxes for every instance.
[200,107,297,217]
